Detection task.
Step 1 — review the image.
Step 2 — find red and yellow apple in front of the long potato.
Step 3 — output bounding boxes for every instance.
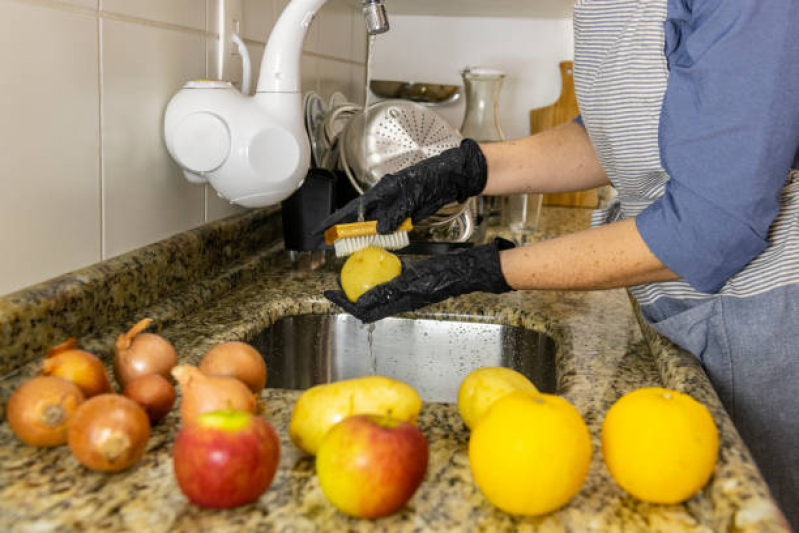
[316,415,428,518]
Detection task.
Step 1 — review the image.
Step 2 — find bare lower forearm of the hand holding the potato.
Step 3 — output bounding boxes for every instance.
[499,219,678,290]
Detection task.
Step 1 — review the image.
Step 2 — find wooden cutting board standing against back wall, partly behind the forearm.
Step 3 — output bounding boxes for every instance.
[530,61,599,207]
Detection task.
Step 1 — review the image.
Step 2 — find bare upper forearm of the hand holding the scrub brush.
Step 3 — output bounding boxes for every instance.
[480,122,608,195]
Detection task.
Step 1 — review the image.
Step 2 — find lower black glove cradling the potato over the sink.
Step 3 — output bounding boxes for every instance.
[325,239,514,323]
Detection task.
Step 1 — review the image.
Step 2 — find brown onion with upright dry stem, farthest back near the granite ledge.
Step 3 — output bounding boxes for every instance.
[114,318,178,389]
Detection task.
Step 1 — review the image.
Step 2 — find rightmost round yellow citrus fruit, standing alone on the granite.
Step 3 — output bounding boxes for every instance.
[602,388,719,503]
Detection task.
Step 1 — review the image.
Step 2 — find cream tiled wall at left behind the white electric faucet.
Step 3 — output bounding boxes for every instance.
[0,0,366,295]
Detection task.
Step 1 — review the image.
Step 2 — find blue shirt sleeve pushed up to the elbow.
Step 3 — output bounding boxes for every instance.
[636,0,799,292]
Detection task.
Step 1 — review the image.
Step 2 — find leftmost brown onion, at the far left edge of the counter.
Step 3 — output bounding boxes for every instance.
[6,376,85,446]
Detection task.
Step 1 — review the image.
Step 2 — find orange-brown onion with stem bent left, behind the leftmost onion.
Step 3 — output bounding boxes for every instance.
[42,338,111,398]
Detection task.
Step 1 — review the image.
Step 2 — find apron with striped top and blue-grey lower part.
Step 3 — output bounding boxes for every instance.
[574,0,799,531]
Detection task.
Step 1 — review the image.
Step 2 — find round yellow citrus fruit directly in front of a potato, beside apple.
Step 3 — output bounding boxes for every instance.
[469,391,591,516]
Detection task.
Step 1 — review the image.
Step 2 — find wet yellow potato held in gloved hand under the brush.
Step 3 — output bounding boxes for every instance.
[341,246,402,302]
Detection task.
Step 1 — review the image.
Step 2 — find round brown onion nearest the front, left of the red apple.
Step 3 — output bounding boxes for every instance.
[67,394,150,472]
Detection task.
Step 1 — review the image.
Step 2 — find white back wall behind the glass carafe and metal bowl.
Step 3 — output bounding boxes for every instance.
[372,15,574,139]
